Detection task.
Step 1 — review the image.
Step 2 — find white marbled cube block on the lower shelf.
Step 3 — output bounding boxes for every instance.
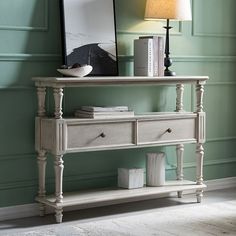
[118,168,144,189]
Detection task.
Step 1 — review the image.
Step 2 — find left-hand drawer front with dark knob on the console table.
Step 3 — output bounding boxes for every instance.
[67,122,134,149]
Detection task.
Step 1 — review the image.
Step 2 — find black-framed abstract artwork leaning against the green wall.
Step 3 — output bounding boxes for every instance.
[61,0,118,76]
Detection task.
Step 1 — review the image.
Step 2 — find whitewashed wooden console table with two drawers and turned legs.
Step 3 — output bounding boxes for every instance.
[33,76,208,223]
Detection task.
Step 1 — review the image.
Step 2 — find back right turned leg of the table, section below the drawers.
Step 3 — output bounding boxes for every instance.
[176,144,184,198]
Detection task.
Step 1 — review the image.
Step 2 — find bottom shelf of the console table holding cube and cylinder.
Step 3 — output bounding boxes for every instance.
[36,180,206,208]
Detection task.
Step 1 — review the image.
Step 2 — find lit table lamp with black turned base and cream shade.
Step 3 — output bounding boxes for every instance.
[144,0,192,76]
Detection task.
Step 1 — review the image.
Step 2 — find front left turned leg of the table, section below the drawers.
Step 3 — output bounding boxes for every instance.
[54,155,64,223]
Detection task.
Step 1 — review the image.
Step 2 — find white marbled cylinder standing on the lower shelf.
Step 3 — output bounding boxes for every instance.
[146,152,165,186]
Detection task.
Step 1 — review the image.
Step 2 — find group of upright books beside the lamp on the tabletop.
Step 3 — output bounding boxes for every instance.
[134,36,164,76]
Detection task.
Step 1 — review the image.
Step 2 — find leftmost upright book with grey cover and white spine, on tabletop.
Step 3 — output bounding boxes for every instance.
[134,38,153,76]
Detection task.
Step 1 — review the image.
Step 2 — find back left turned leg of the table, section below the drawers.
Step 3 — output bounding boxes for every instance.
[37,150,47,216]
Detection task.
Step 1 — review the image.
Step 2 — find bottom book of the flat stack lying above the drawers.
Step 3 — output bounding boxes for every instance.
[75,110,134,119]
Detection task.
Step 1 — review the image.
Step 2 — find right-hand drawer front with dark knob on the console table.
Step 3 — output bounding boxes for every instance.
[138,118,196,144]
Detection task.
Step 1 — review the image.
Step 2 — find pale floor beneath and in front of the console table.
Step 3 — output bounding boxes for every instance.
[0,188,236,236]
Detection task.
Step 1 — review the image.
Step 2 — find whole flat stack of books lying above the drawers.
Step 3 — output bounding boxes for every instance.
[75,106,134,119]
